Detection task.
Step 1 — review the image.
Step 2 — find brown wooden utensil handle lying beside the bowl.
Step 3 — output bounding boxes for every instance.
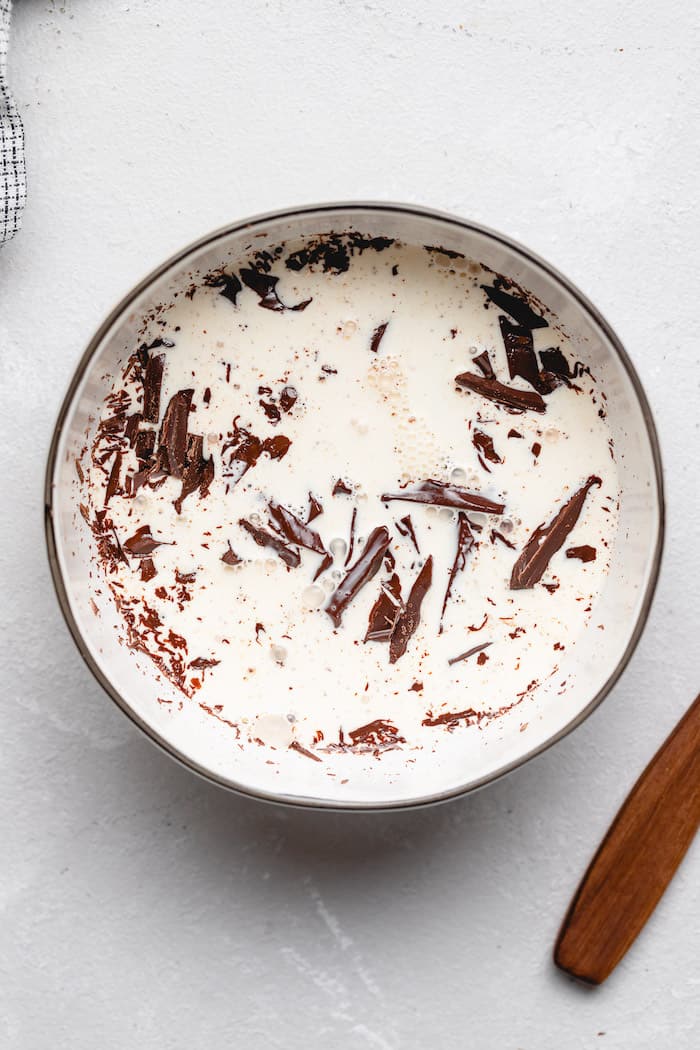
[554,696,700,985]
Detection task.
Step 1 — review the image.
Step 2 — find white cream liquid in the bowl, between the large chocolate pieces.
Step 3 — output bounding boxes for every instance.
[81,245,619,758]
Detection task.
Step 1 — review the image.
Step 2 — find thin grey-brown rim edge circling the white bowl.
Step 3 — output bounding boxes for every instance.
[44,201,665,812]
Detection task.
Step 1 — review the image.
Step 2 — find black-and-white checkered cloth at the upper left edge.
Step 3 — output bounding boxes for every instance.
[0,0,26,245]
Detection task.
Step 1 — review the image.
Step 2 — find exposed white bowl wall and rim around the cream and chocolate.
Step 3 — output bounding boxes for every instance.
[45,203,663,810]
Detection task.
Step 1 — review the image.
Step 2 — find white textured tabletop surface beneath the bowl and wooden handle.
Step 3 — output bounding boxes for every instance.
[0,0,700,1050]
